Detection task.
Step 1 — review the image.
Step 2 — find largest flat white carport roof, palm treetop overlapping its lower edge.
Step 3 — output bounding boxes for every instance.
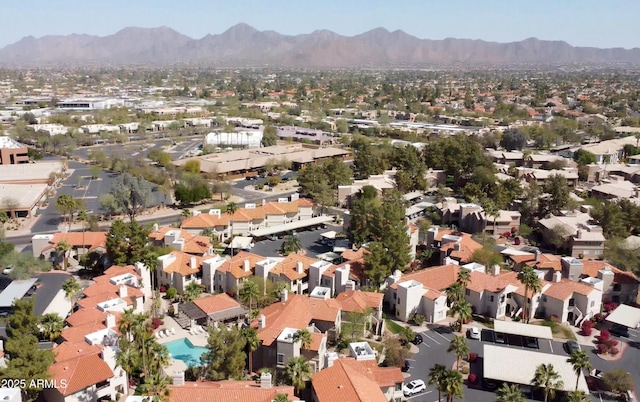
[482,344,589,394]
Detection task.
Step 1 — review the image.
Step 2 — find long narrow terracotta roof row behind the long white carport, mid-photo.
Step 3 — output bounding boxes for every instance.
[180,198,313,229]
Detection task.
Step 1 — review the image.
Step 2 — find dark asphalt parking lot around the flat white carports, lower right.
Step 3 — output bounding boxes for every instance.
[405,325,640,402]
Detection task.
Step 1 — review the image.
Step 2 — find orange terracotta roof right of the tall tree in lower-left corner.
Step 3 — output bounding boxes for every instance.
[49,354,113,396]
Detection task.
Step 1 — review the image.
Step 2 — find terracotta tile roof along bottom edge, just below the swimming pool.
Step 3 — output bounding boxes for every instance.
[169,381,299,402]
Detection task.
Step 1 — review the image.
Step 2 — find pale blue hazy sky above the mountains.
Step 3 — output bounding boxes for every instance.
[0,0,640,48]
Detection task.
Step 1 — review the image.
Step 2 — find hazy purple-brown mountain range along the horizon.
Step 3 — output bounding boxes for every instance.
[0,24,640,68]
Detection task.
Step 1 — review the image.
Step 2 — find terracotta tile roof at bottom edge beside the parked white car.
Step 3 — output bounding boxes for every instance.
[311,358,403,402]
